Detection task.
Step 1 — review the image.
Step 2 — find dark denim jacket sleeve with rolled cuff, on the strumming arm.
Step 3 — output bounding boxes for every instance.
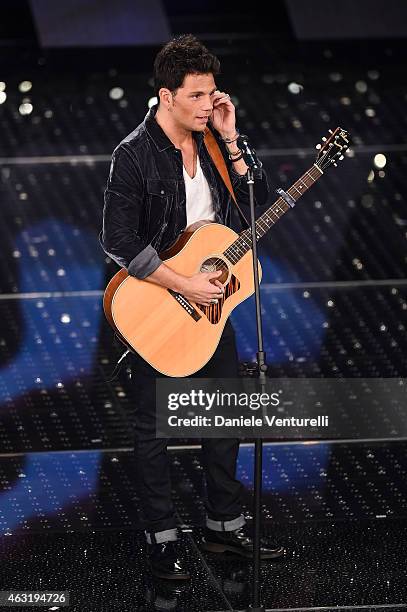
[99,144,162,278]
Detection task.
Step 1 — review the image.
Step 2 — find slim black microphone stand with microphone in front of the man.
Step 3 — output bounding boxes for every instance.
[237,135,267,612]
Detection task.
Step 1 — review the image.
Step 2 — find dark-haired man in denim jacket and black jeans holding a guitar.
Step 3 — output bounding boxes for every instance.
[100,35,283,579]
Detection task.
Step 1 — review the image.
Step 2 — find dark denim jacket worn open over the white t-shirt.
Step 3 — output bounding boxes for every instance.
[99,106,269,278]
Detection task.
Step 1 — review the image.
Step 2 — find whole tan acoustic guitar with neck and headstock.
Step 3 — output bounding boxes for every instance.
[103,127,349,377]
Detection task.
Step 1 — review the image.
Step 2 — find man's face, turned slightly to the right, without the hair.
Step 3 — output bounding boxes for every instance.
[167,74,216,132]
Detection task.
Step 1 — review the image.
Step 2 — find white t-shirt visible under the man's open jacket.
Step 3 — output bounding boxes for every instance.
[183,155,215,227]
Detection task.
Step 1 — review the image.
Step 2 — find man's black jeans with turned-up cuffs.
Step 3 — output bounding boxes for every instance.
[131,321,244,541]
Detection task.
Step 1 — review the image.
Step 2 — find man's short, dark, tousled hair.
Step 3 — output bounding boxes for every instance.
[154,34,220,97]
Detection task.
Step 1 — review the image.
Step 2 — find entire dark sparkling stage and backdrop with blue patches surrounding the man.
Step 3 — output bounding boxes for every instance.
[0,0,407,612]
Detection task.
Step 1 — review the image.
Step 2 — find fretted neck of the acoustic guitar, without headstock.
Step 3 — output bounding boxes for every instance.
[223,164,323,264]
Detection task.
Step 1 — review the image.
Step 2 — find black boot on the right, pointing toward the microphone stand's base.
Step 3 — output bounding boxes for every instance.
[201,527,284,559]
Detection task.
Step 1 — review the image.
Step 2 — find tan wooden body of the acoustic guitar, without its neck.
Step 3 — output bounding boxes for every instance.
[103,223,261,377]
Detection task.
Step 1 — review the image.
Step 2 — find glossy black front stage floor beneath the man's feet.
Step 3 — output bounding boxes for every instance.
[0,441,407,612]
